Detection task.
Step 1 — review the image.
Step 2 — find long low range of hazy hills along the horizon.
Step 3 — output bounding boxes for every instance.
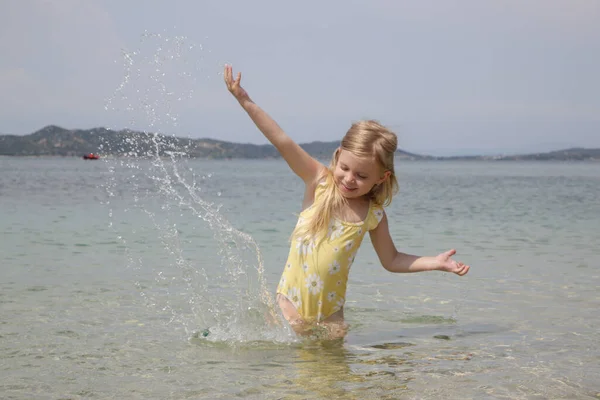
[0,125,600,161]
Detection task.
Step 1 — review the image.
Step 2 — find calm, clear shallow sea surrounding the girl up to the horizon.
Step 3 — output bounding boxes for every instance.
[0,157,600,399]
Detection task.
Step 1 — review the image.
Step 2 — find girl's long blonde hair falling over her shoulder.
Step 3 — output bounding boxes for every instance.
[291,120,398,242]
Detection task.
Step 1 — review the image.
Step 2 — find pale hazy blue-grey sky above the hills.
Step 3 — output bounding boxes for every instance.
[0,0,600,155]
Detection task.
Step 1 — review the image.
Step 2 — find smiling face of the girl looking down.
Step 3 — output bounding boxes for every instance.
[333,150,389,199]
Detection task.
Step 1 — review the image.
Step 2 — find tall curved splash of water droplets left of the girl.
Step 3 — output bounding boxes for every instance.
[101,33,292,343]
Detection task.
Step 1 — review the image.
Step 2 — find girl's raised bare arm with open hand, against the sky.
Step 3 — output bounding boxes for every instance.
[223,65,325,185]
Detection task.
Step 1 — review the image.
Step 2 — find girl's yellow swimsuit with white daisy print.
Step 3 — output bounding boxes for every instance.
[277,184,383,322]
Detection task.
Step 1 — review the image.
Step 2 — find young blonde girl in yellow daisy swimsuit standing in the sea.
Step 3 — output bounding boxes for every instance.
[224,65,469,336]
